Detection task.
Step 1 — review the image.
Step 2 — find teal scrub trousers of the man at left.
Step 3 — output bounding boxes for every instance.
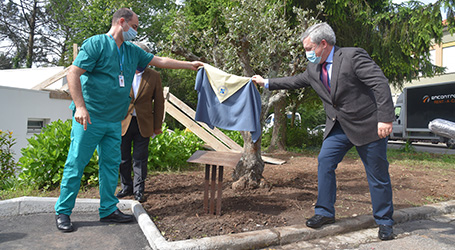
[55,116,122,218]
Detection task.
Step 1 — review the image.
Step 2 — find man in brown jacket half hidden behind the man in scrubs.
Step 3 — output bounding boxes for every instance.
[117,42,164,202]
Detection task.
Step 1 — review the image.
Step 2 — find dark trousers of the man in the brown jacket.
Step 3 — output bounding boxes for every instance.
[120,116,150,193]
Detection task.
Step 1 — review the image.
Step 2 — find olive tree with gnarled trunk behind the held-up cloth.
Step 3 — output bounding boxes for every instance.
[164,0,322,189]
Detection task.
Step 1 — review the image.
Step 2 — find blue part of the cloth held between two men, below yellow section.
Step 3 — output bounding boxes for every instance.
[195,68,261,142]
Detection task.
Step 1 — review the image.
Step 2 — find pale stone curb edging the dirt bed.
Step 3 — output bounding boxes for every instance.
[0,197,455,250]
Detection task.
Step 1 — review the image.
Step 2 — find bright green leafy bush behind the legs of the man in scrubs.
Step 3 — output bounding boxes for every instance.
[19,120,98,189]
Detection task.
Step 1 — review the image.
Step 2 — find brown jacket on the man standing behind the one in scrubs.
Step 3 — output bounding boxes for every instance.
[122,68,164,137]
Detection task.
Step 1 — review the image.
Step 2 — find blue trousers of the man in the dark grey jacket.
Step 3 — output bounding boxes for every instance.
[315,122,393,225]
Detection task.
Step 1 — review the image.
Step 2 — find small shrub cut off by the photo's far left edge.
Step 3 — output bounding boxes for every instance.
[0,130,16,189]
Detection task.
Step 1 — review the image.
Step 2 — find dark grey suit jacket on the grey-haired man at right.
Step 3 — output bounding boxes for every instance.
[269,46,395,146]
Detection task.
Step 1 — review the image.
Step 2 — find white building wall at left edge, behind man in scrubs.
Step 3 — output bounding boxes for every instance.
[0,86,72,161]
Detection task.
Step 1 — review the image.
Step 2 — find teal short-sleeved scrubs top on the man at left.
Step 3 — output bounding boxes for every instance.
[70,34,153,122]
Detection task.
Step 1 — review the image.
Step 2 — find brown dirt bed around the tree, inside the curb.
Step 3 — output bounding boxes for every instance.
[108,153,455,241]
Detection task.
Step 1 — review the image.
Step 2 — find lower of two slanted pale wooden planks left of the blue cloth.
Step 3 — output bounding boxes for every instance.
[166,100,229,151]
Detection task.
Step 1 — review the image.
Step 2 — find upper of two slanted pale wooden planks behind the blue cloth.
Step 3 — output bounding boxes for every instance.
[168,93,243,152]
